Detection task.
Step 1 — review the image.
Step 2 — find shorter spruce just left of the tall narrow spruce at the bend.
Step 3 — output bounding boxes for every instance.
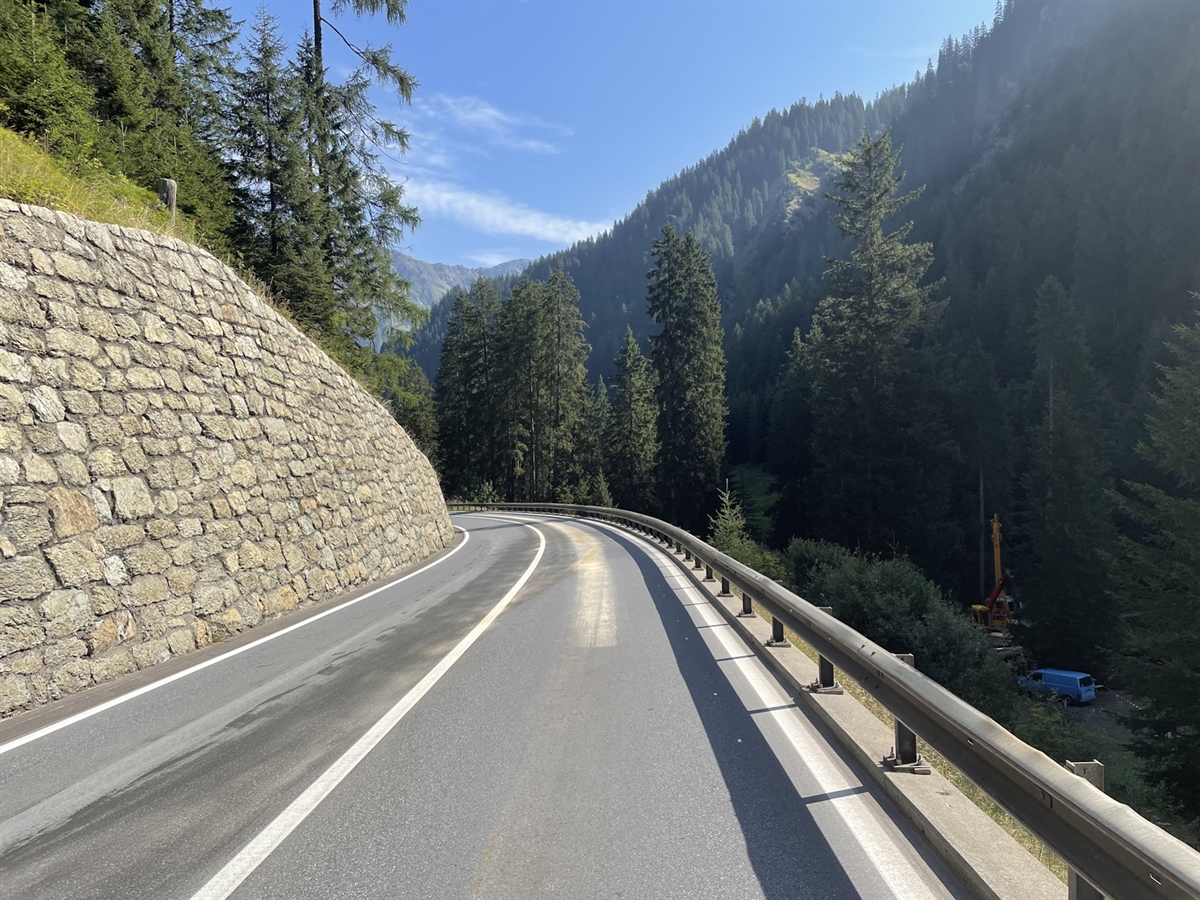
[605,328,658,512]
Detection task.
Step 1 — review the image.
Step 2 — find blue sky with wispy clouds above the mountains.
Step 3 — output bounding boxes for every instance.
[225,0,995,265]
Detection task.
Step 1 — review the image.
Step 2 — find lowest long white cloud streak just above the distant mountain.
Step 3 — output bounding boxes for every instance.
[404,178,607,247]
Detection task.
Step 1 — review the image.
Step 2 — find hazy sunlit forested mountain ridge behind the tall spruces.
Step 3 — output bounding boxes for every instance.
[416,0,1156,391]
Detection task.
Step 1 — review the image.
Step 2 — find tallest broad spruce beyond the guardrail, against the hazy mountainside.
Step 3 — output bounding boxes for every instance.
[799,130,961,571]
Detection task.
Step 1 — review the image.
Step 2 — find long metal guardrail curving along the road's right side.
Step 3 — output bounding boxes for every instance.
[450,503,1200,900]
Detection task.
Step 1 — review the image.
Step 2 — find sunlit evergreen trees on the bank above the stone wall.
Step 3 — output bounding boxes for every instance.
[0,0,432,434]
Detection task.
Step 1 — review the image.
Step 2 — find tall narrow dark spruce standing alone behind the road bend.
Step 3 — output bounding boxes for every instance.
[647,224,726,534]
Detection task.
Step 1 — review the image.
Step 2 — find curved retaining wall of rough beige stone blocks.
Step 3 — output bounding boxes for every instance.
[0,199,451,715]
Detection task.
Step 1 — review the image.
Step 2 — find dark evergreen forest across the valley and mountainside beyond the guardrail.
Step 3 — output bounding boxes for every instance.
[414,0,1200,840]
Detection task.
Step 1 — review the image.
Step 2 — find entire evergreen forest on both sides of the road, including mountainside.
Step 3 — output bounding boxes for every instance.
[0,0,1200,844]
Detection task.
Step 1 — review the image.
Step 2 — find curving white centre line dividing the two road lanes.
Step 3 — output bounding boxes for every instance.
[192,522,546,900]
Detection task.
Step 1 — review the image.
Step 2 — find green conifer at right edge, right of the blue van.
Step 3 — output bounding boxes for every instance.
[1114,325,1200,821]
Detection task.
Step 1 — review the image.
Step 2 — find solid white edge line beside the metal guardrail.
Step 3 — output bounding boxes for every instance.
[590,527,935,900]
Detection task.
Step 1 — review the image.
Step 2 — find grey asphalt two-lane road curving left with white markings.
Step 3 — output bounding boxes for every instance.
[0,514,968,900]
